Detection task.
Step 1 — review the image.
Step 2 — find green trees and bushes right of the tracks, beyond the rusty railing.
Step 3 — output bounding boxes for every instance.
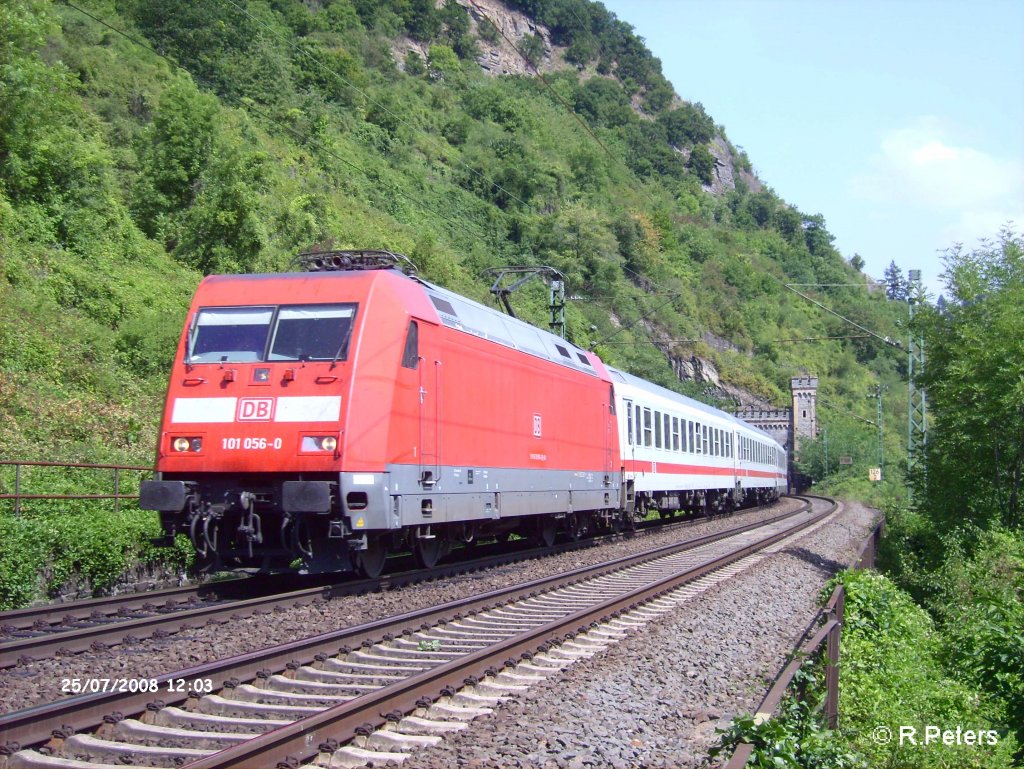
[782,236,1024,767]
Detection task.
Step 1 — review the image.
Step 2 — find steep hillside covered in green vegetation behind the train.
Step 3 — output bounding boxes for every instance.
[0,0,900,610]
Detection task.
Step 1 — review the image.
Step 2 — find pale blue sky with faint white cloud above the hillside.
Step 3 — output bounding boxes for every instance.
[604,0,1024,294]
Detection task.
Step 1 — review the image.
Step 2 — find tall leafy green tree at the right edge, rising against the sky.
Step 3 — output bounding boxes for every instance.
[913,229,1024,527]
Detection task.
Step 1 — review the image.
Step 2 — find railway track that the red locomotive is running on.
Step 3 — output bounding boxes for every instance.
[0,501,794,670]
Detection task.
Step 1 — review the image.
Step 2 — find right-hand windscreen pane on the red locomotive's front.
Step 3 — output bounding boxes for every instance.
[267,304,355,360]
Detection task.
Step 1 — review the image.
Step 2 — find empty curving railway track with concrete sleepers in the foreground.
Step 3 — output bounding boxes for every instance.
[0,500,836,769]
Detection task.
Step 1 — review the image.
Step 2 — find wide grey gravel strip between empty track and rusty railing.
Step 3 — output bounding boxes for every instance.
[402,503,878,769]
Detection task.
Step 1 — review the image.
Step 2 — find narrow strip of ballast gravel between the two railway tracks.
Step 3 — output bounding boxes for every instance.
[0,499,801,713]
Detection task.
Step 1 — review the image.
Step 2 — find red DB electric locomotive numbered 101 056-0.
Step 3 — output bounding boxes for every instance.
[140,252,629,575]
